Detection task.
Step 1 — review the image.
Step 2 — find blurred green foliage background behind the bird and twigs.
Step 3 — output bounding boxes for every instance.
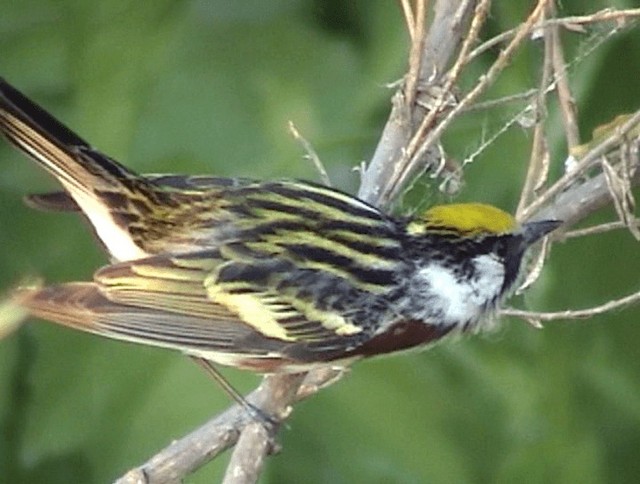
[0,0,640,484]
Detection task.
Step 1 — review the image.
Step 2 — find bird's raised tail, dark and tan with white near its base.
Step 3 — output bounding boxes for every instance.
[0,78,152,260]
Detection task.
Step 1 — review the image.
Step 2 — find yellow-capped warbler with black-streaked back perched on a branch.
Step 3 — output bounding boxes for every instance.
[0,81,560,373]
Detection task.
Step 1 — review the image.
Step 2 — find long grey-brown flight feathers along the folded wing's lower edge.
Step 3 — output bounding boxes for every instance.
[13,282,283,364]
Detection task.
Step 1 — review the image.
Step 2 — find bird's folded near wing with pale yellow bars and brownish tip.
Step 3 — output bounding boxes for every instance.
[17,251,376,371]
